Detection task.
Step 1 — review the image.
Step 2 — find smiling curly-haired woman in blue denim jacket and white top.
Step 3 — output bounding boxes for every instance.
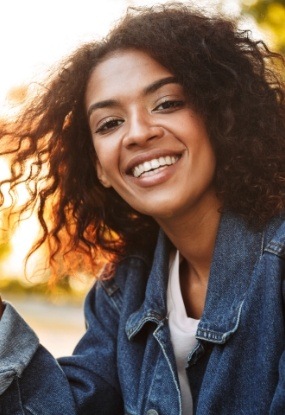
[0,5,285,415]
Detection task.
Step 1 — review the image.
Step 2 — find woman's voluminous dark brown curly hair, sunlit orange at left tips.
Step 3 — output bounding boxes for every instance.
[0,3,285,276]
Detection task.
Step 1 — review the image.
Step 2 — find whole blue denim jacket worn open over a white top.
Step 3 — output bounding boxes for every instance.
[0,214,285,415]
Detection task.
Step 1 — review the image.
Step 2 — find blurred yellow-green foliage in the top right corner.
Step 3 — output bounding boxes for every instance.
[241,0,285,54]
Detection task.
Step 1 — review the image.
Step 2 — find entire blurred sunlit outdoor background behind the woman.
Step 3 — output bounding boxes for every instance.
[0,0,285,356]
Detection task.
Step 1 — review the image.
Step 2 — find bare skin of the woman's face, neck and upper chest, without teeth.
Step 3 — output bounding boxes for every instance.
[85,50,221,318]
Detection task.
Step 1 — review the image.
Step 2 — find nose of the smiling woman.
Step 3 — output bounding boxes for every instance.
[124,111,163,148]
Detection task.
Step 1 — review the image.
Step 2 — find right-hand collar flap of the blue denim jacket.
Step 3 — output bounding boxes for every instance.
[197,214,264,344]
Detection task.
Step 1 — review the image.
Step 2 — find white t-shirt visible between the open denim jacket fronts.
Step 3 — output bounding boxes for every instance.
[167,251,199,415]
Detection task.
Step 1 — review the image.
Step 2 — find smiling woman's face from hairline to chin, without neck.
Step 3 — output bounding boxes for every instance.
[85,50,215,222]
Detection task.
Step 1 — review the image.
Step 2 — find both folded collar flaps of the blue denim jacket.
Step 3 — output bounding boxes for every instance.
[126,213,280,344]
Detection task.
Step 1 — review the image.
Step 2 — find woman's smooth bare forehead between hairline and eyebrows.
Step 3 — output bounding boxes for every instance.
[86,50,172,105]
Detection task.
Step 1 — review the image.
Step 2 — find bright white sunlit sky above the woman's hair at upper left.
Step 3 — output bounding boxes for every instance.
[0,0,239,113]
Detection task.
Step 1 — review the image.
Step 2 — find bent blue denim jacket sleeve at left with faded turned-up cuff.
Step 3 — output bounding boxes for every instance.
[0,287,123,415]
